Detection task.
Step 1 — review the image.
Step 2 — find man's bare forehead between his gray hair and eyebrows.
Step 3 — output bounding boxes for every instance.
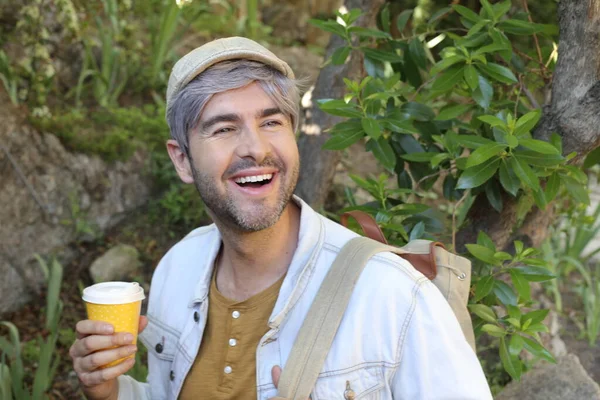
[201,82,277,119]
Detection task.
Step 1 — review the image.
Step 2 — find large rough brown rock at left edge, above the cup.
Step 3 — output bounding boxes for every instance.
[0,90,151,315]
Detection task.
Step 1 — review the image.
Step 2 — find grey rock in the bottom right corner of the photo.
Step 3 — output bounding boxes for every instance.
[496,354,600,400]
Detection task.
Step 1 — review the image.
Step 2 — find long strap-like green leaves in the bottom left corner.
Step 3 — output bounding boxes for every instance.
[0,255,63,400]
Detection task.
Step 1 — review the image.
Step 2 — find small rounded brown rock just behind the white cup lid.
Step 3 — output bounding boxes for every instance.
[90,244,141,283]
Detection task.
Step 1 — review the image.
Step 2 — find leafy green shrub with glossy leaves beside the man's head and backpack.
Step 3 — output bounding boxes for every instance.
[311,0,576,379]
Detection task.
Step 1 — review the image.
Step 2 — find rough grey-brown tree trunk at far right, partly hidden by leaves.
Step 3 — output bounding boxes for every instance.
[457,0,600,251]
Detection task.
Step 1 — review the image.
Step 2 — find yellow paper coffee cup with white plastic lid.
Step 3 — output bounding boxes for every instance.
[83,282,145,368]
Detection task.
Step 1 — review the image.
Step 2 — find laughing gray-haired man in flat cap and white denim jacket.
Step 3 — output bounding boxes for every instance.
[71,38,491,400]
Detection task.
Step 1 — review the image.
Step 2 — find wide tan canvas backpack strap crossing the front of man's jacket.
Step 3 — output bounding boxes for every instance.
[275,237,403,400]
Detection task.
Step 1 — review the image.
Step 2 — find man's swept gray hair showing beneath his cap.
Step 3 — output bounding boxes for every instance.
[167,59,300,156]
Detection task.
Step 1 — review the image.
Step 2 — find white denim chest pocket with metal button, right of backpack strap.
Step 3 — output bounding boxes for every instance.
[312,366,385,400]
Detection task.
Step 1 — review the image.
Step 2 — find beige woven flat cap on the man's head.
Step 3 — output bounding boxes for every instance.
[167,37,294,110]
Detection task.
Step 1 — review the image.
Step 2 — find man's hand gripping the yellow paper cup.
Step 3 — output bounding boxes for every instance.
[69,316,148,400]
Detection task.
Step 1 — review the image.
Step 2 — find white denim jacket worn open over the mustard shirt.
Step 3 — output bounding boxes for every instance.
[119,197,492,400]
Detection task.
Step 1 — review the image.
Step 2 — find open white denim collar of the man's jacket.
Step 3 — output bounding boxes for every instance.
[189,195,324,322]
